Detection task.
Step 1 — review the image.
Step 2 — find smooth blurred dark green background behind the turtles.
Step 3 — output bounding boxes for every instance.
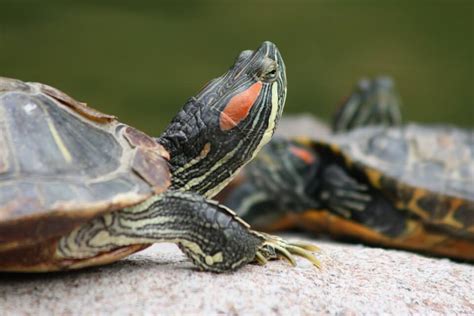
[0,0,474,135]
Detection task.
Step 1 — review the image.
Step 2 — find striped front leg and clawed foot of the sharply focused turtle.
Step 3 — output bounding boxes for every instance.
[57,191,317,272]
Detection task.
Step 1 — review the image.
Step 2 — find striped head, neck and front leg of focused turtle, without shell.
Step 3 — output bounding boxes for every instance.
[56,42,318,272]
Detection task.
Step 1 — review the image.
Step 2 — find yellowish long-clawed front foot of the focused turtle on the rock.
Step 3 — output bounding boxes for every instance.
[255,233,321,268]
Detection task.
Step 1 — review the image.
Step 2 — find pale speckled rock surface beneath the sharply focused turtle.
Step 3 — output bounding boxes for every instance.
[0,236,474,315]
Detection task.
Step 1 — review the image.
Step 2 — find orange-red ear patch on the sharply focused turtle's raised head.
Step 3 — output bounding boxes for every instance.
[219,81,262,131]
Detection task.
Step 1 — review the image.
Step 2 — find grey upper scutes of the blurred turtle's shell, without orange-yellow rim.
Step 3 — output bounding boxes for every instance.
[334,124,474,200]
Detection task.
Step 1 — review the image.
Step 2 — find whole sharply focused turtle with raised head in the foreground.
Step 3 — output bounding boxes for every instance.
[0,42,318,272]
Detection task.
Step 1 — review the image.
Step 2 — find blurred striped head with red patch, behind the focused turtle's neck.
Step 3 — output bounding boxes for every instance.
[221,138,320,230]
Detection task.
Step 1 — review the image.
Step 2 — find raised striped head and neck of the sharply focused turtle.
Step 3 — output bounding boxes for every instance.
[158,42,286,197]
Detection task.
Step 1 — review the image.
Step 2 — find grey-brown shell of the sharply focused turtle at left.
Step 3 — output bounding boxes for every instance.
[0,77,170,252]
